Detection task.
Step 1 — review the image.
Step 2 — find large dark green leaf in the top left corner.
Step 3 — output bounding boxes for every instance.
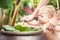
[0,0,13,10]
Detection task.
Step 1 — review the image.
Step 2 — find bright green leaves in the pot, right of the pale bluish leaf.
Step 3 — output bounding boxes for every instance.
[15,25,41,32]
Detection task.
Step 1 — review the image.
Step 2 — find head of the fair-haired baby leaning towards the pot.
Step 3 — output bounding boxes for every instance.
[38,5,56,24]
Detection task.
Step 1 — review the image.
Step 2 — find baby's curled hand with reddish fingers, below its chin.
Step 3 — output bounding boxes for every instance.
[42,23,56,33]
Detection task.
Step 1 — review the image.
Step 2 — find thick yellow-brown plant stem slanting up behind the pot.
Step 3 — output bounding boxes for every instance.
[9,0,20,26]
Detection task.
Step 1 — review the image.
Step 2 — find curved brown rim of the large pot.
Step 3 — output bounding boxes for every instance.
[1,30,43,36]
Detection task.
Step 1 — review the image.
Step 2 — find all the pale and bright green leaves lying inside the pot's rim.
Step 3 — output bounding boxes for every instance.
[3,25,40,32]
